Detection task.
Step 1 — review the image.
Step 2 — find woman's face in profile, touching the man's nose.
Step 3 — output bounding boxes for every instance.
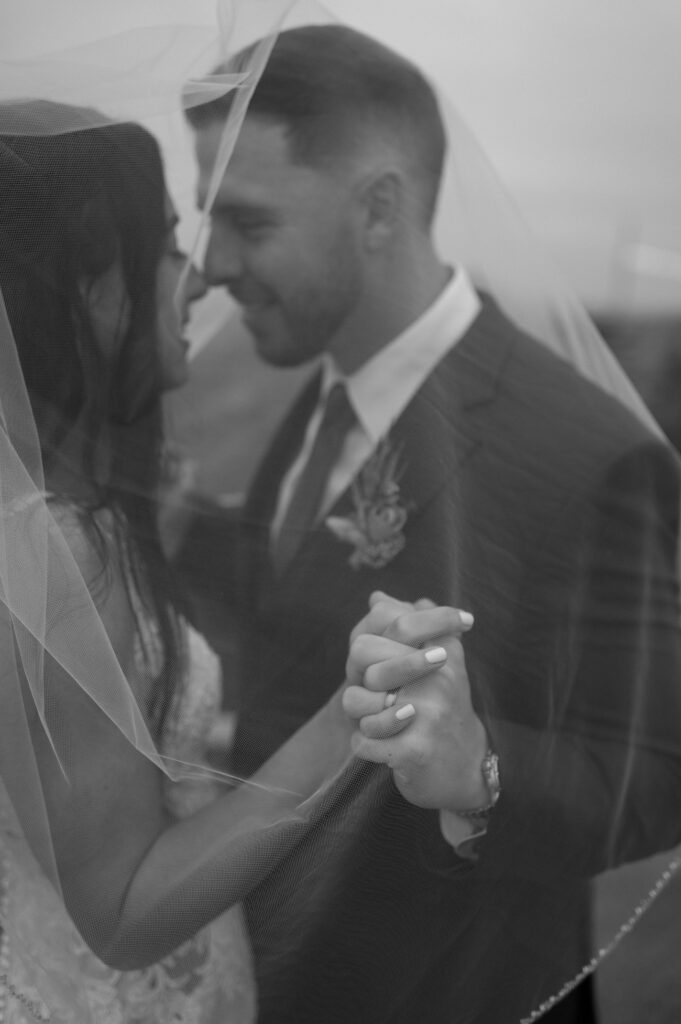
[156,198,206,391]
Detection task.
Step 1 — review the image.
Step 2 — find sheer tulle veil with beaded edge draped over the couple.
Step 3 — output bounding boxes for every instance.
[0,0,681,1024]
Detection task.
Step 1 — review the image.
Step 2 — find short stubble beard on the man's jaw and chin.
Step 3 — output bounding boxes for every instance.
[229,229,363,367]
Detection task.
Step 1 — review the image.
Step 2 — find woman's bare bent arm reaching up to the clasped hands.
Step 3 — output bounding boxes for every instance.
[25,509,350,969]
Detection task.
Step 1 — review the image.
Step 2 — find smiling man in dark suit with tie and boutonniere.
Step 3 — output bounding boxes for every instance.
[189,27,681,1024]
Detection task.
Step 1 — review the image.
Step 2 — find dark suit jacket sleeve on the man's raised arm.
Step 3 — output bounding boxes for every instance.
[481,442,681,877]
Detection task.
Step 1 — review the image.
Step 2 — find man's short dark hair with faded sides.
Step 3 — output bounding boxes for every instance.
[186,25,446,229]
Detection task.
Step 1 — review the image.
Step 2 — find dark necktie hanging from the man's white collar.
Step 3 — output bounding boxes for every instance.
[273,383,356,572]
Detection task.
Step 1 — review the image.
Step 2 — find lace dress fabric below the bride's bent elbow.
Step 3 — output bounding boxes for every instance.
[0,839,255,1024]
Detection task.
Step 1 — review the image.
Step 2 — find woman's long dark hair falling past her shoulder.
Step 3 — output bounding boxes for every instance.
[0,101,180,728]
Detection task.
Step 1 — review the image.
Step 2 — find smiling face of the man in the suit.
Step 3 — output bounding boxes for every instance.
[197,118,361,366]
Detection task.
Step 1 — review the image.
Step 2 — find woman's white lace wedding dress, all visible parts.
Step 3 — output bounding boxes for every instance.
[0,598,255,1024]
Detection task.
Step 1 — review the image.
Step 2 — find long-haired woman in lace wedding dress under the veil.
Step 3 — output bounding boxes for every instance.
[0,103,458,1024]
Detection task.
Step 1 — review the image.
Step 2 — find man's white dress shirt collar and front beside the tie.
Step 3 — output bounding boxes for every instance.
[270,267,480,539]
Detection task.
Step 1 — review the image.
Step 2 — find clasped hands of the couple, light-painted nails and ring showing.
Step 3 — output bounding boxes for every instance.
[343,591,490,813]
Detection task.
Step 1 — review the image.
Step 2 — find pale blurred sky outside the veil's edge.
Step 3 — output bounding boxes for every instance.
[0,0,681,311]
